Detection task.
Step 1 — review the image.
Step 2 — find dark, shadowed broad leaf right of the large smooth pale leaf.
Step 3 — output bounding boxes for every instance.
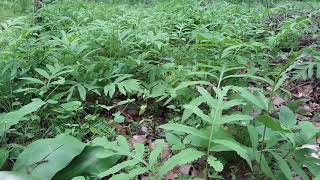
[53,145,121,180]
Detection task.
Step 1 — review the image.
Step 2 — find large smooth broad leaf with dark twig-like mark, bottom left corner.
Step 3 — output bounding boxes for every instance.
[13,134,85,179]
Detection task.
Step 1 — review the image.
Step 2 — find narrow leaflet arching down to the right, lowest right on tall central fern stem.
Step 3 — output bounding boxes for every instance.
[212,139,252,169]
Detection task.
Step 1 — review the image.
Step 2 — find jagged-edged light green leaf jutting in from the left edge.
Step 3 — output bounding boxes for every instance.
[0,99,46,132]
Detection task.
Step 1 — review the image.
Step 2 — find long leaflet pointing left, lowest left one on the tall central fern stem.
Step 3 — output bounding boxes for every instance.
[159,123,209,140]
